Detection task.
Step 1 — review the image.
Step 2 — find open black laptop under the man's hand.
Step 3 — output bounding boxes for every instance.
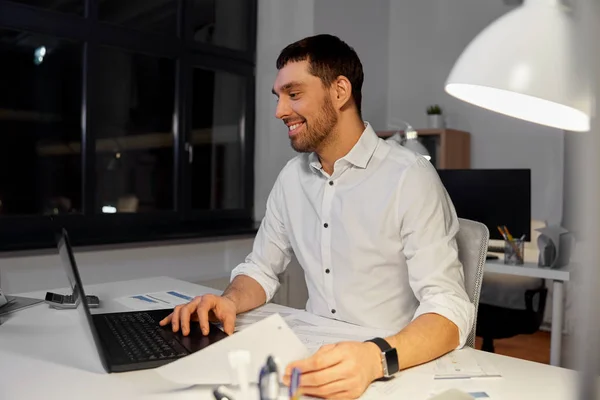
[56,229,227,373]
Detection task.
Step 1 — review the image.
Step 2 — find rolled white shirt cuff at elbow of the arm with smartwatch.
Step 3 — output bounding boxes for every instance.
[413,294,475,349]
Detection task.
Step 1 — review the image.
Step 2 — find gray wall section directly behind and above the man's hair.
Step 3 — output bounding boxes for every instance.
[315,0,390,130]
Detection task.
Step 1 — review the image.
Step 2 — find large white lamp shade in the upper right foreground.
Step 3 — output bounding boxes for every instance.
[446,0,591,131]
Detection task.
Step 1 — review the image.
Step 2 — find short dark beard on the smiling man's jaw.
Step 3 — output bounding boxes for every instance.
[291,95,338,153]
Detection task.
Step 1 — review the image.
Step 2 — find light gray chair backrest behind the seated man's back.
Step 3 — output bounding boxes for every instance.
[456,218,490,348]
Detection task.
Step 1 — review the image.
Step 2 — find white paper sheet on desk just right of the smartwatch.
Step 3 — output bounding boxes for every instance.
[434,349,502,379]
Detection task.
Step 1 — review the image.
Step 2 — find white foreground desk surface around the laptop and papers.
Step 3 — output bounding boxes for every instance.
[0,276,577,400]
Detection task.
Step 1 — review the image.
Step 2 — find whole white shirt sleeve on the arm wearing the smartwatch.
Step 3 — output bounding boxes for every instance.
[400,159,475,348]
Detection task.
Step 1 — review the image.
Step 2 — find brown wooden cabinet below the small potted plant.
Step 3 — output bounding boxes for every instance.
[377,129,471,169]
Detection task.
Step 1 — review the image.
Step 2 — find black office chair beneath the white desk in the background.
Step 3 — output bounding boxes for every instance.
[477,279,548,353]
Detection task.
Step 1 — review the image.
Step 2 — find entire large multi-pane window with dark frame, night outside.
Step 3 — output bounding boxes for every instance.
[0,0,257,251]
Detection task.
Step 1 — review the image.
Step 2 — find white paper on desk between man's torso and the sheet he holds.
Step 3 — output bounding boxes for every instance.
[285,312,395,353]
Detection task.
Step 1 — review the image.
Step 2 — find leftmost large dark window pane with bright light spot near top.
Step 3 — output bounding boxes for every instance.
[0,29,82,216]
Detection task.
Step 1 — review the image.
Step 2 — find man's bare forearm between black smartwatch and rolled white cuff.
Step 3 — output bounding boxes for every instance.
[386,313,459,369]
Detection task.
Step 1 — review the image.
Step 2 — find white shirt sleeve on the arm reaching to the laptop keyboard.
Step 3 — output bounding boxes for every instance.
[231,170,292,302]
